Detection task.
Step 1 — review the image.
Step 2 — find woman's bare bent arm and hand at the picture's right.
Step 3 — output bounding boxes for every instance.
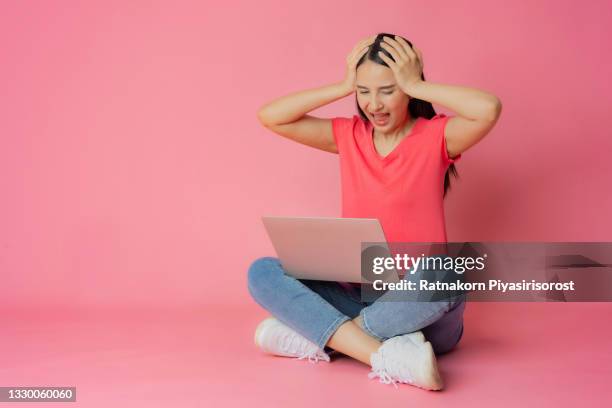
[379,37,501,158]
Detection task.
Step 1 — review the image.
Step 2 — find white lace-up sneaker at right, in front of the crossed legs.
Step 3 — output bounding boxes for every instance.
[368,335,444,390]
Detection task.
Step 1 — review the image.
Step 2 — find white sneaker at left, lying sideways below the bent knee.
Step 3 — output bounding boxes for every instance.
[255,317,330,363]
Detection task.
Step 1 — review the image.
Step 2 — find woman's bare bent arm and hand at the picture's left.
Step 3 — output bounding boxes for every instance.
[257,36,376,153]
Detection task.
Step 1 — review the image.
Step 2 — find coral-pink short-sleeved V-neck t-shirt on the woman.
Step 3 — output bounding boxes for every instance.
[332,114,461,242]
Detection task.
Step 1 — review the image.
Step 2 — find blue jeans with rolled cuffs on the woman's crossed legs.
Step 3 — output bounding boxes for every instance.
[248,257,465,354]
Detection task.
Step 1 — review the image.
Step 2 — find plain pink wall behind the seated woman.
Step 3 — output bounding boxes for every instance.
[0,0,612,404]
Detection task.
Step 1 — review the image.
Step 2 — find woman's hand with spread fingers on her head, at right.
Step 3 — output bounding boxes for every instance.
[378,36,423,95]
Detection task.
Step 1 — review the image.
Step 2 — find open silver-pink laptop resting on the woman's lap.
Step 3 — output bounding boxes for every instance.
[262,216,387,283]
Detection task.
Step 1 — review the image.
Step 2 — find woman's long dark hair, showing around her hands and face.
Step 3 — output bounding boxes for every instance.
[355,33,459,197]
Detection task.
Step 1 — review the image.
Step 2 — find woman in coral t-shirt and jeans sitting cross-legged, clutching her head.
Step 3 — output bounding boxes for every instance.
[248,33,501,390]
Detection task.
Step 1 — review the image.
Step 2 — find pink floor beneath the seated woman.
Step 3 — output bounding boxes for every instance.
[0,303,612,408]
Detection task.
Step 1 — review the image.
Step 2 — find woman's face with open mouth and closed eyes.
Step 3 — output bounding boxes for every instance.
[356,60,410,132]
